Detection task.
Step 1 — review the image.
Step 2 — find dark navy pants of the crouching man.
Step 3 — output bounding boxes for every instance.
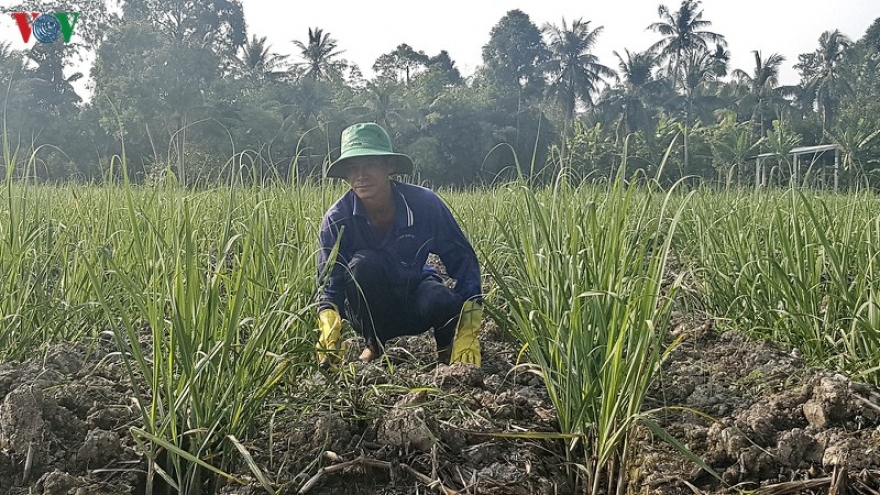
[345,250,464,352]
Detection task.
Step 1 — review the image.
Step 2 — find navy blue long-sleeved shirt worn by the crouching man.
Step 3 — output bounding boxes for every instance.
[318,181,482,311]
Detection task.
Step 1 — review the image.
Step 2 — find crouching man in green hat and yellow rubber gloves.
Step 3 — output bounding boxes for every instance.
[317,123,483,367]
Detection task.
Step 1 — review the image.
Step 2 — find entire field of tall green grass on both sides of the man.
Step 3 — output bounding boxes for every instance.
[0,144,880,494]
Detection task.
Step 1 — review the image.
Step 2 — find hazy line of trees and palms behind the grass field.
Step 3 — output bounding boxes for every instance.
[0,0,880,185]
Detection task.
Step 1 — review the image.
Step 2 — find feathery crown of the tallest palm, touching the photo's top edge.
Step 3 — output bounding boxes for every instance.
[648,0,727,84]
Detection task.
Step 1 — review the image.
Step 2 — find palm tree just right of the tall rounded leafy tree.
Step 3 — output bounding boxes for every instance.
[543,19,617,154]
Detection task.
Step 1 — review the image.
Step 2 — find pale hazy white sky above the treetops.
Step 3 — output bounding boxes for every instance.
[242,0,880,84]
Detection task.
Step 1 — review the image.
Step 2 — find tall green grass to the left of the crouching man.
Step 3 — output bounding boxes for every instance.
[0,146,348,494]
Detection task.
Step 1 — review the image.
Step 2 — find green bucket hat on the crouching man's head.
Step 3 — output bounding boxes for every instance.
[327,122,413,179]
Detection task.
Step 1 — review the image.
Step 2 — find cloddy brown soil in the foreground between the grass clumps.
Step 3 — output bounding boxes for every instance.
[0,320,880,495]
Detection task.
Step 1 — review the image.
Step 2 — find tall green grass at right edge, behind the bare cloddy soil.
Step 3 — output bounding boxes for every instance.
[677,189,880,383]
